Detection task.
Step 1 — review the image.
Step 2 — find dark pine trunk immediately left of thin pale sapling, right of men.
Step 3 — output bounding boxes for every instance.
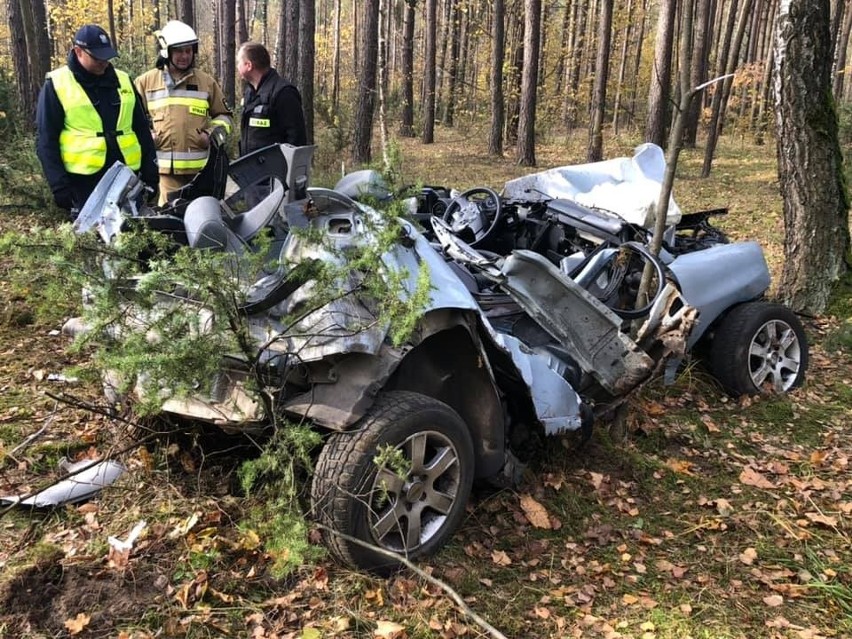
[352,0,379,165]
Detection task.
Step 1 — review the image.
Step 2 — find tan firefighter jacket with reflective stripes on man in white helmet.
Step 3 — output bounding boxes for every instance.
[136,69,233,175]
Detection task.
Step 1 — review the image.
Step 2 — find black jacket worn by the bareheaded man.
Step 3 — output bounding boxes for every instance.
[240,69,307,155]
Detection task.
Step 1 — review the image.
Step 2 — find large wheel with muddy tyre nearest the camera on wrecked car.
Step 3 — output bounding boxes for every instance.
[311,391,475,574]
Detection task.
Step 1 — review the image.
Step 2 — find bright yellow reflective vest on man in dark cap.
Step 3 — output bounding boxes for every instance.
[47,66,142,175]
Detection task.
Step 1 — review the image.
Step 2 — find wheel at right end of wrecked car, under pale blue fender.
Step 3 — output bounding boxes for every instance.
[710,302,808,397]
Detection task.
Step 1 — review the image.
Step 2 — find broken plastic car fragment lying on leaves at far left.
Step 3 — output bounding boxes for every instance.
[0,459,127,508]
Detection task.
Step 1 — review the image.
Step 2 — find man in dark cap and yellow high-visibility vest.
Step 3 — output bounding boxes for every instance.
[36,24,158,211]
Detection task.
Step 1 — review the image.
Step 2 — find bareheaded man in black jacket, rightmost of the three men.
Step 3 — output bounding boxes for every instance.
[237,42,308,155]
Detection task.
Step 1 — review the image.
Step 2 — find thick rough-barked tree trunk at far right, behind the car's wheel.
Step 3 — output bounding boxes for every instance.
[774,0,850,315]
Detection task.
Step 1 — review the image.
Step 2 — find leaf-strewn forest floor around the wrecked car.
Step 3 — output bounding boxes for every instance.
[0,129,852,639]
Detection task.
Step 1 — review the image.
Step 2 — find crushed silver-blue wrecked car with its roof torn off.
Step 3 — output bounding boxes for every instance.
[66,145,807,571]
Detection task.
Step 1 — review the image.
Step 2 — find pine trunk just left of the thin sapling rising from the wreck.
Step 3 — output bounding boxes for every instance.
[645,0,677,146]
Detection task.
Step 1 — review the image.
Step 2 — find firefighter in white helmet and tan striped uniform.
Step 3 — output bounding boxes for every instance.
[136,20,233,204]
